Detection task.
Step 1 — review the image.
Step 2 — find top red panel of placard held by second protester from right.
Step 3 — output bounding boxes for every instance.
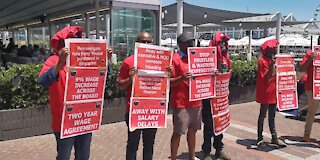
[276,55,295,73]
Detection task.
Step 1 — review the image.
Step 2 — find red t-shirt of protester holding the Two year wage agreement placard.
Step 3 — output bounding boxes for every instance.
[39,55,66,132]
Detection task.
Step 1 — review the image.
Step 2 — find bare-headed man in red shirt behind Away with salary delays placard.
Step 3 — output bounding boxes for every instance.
[119,32,157,160]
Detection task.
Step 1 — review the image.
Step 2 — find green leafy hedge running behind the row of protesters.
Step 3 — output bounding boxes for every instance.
[0,59,257,110]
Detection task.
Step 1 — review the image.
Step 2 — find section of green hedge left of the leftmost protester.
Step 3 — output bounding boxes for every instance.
[0,64,48,110]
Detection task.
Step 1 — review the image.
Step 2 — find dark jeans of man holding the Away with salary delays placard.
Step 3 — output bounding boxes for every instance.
[125,114,157,160]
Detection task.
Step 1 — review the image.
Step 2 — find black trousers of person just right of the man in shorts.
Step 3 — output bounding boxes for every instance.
[202,99,224,154]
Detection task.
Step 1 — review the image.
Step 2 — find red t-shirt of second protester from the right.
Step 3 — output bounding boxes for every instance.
[256,56,277,104]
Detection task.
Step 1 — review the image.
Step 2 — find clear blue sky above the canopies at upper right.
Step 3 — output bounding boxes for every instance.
[162,0,320,21]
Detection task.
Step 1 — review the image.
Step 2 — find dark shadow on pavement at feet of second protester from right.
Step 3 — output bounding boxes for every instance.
[236,139,282,152]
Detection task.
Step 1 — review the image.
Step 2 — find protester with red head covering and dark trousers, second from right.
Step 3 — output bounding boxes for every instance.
[256,39,286,147]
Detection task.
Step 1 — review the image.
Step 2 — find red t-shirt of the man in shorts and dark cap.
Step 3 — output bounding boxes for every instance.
[170,53,201,108]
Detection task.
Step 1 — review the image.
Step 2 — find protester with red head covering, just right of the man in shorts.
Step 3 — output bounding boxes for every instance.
[202,32,231,160]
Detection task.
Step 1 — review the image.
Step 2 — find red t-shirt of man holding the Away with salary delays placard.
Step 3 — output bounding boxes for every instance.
[119,55,134,113]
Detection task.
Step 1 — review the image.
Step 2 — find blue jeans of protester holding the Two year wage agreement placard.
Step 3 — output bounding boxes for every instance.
[54,132,92,160]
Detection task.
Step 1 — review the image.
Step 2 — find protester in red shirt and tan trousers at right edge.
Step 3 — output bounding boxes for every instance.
[299,50,319,142]
